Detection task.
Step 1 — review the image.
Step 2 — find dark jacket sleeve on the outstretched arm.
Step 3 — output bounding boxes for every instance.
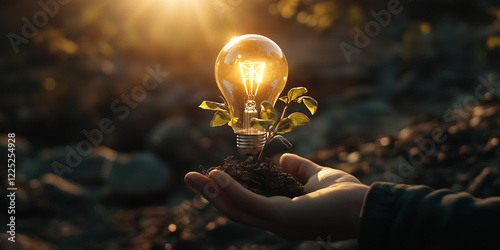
[359,182,500,250]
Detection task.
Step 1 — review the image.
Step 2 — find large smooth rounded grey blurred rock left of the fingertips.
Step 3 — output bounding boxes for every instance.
[106,152,172,198]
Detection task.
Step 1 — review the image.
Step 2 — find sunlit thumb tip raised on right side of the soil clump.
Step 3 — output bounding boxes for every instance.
[280,154,323,181]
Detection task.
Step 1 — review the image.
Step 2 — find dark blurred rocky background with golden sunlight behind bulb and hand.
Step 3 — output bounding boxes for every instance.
[0,0,500,249]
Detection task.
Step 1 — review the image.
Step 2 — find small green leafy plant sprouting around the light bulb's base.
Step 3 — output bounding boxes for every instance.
[199,87,318,160]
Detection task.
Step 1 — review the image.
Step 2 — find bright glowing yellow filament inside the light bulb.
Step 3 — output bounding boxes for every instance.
[239,62,266,97]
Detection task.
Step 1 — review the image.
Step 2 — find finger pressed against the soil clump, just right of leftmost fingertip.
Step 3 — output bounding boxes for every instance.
[209,170,291,222]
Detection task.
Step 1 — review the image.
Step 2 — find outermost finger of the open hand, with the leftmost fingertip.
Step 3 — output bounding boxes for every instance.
[184,172,284,232]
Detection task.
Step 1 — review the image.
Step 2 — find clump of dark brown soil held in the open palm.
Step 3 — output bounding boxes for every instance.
[200,156,304,198]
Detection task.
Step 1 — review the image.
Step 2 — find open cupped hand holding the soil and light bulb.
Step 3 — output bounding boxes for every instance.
[184,154,368,241]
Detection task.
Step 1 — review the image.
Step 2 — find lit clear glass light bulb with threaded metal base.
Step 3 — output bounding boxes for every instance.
[215,35,288,154]
